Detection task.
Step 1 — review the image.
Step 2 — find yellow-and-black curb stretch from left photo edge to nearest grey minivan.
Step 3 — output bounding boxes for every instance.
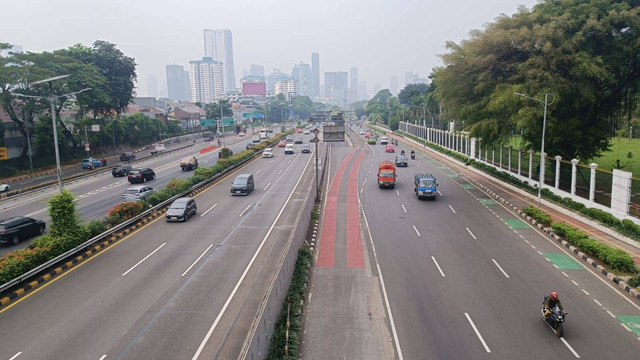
[0,210,166,309]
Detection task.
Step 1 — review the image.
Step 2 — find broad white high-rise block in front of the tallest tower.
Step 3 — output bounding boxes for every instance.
[189,57,224,103]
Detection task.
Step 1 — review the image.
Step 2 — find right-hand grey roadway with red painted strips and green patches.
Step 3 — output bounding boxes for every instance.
[303,124,640,359]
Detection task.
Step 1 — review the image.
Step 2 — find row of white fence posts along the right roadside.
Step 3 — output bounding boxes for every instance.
[398,121,640,224]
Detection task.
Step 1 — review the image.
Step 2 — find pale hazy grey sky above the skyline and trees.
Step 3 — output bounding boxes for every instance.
[0,0,538,96]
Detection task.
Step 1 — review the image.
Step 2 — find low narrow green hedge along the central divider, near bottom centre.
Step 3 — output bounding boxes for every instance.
[267,246,313,360]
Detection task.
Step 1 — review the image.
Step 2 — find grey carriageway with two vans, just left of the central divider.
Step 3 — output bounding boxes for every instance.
[0,128,320,360]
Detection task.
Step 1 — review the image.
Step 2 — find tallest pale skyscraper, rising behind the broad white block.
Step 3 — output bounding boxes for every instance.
[204,29,236,91]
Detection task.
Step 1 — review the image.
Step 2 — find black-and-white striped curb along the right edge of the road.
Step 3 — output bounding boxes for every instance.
[458,172,640,301]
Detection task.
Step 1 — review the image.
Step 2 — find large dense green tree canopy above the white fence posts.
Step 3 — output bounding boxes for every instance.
[435,0,640,160]
